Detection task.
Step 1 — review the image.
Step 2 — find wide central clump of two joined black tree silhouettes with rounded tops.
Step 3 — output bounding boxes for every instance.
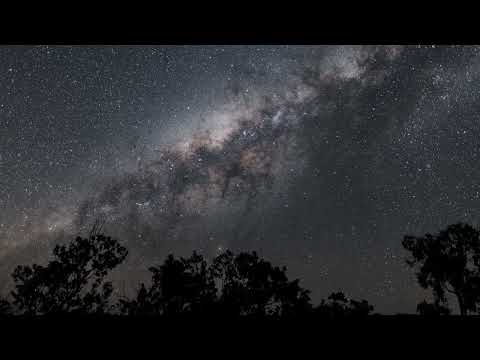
[120,251,311,317]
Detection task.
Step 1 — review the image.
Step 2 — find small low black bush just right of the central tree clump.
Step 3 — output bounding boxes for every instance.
[315,291,374,319]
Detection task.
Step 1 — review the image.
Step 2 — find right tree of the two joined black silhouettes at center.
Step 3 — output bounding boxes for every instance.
[212,251,311,317]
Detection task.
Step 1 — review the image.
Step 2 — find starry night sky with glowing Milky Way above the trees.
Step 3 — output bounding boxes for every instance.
[0,45,480,313]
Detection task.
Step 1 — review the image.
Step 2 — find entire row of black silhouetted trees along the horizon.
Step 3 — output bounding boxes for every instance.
[0,219,480,319]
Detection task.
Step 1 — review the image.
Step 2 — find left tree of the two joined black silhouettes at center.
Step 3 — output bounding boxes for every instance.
[120,252,217,316]
